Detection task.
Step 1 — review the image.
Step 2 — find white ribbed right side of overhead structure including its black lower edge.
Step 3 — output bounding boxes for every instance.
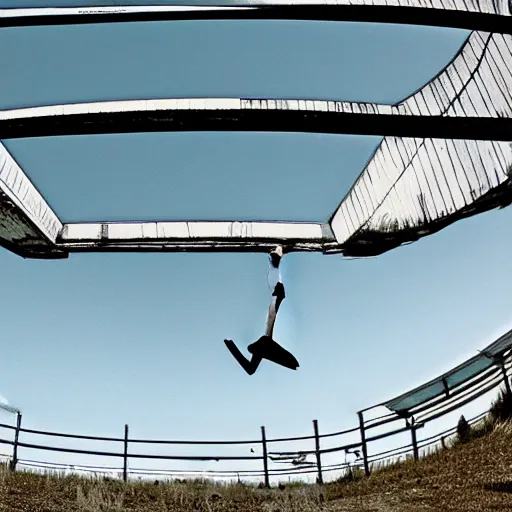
[331,32,512,256]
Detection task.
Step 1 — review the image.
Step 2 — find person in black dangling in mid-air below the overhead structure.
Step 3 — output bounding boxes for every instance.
[224,246,299,375]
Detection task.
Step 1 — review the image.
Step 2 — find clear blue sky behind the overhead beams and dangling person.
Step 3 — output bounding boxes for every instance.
[0,0,512,480]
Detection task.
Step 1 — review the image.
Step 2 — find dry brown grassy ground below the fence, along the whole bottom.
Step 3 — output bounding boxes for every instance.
[0,422,512,512]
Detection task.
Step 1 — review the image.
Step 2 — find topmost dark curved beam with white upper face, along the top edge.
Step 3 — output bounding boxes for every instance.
[0,0,512,34]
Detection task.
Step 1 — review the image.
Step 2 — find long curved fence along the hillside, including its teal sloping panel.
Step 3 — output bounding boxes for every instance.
[0,330,512,486]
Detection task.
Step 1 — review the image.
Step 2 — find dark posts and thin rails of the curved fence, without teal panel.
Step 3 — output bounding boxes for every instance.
[0,355,512,487]
